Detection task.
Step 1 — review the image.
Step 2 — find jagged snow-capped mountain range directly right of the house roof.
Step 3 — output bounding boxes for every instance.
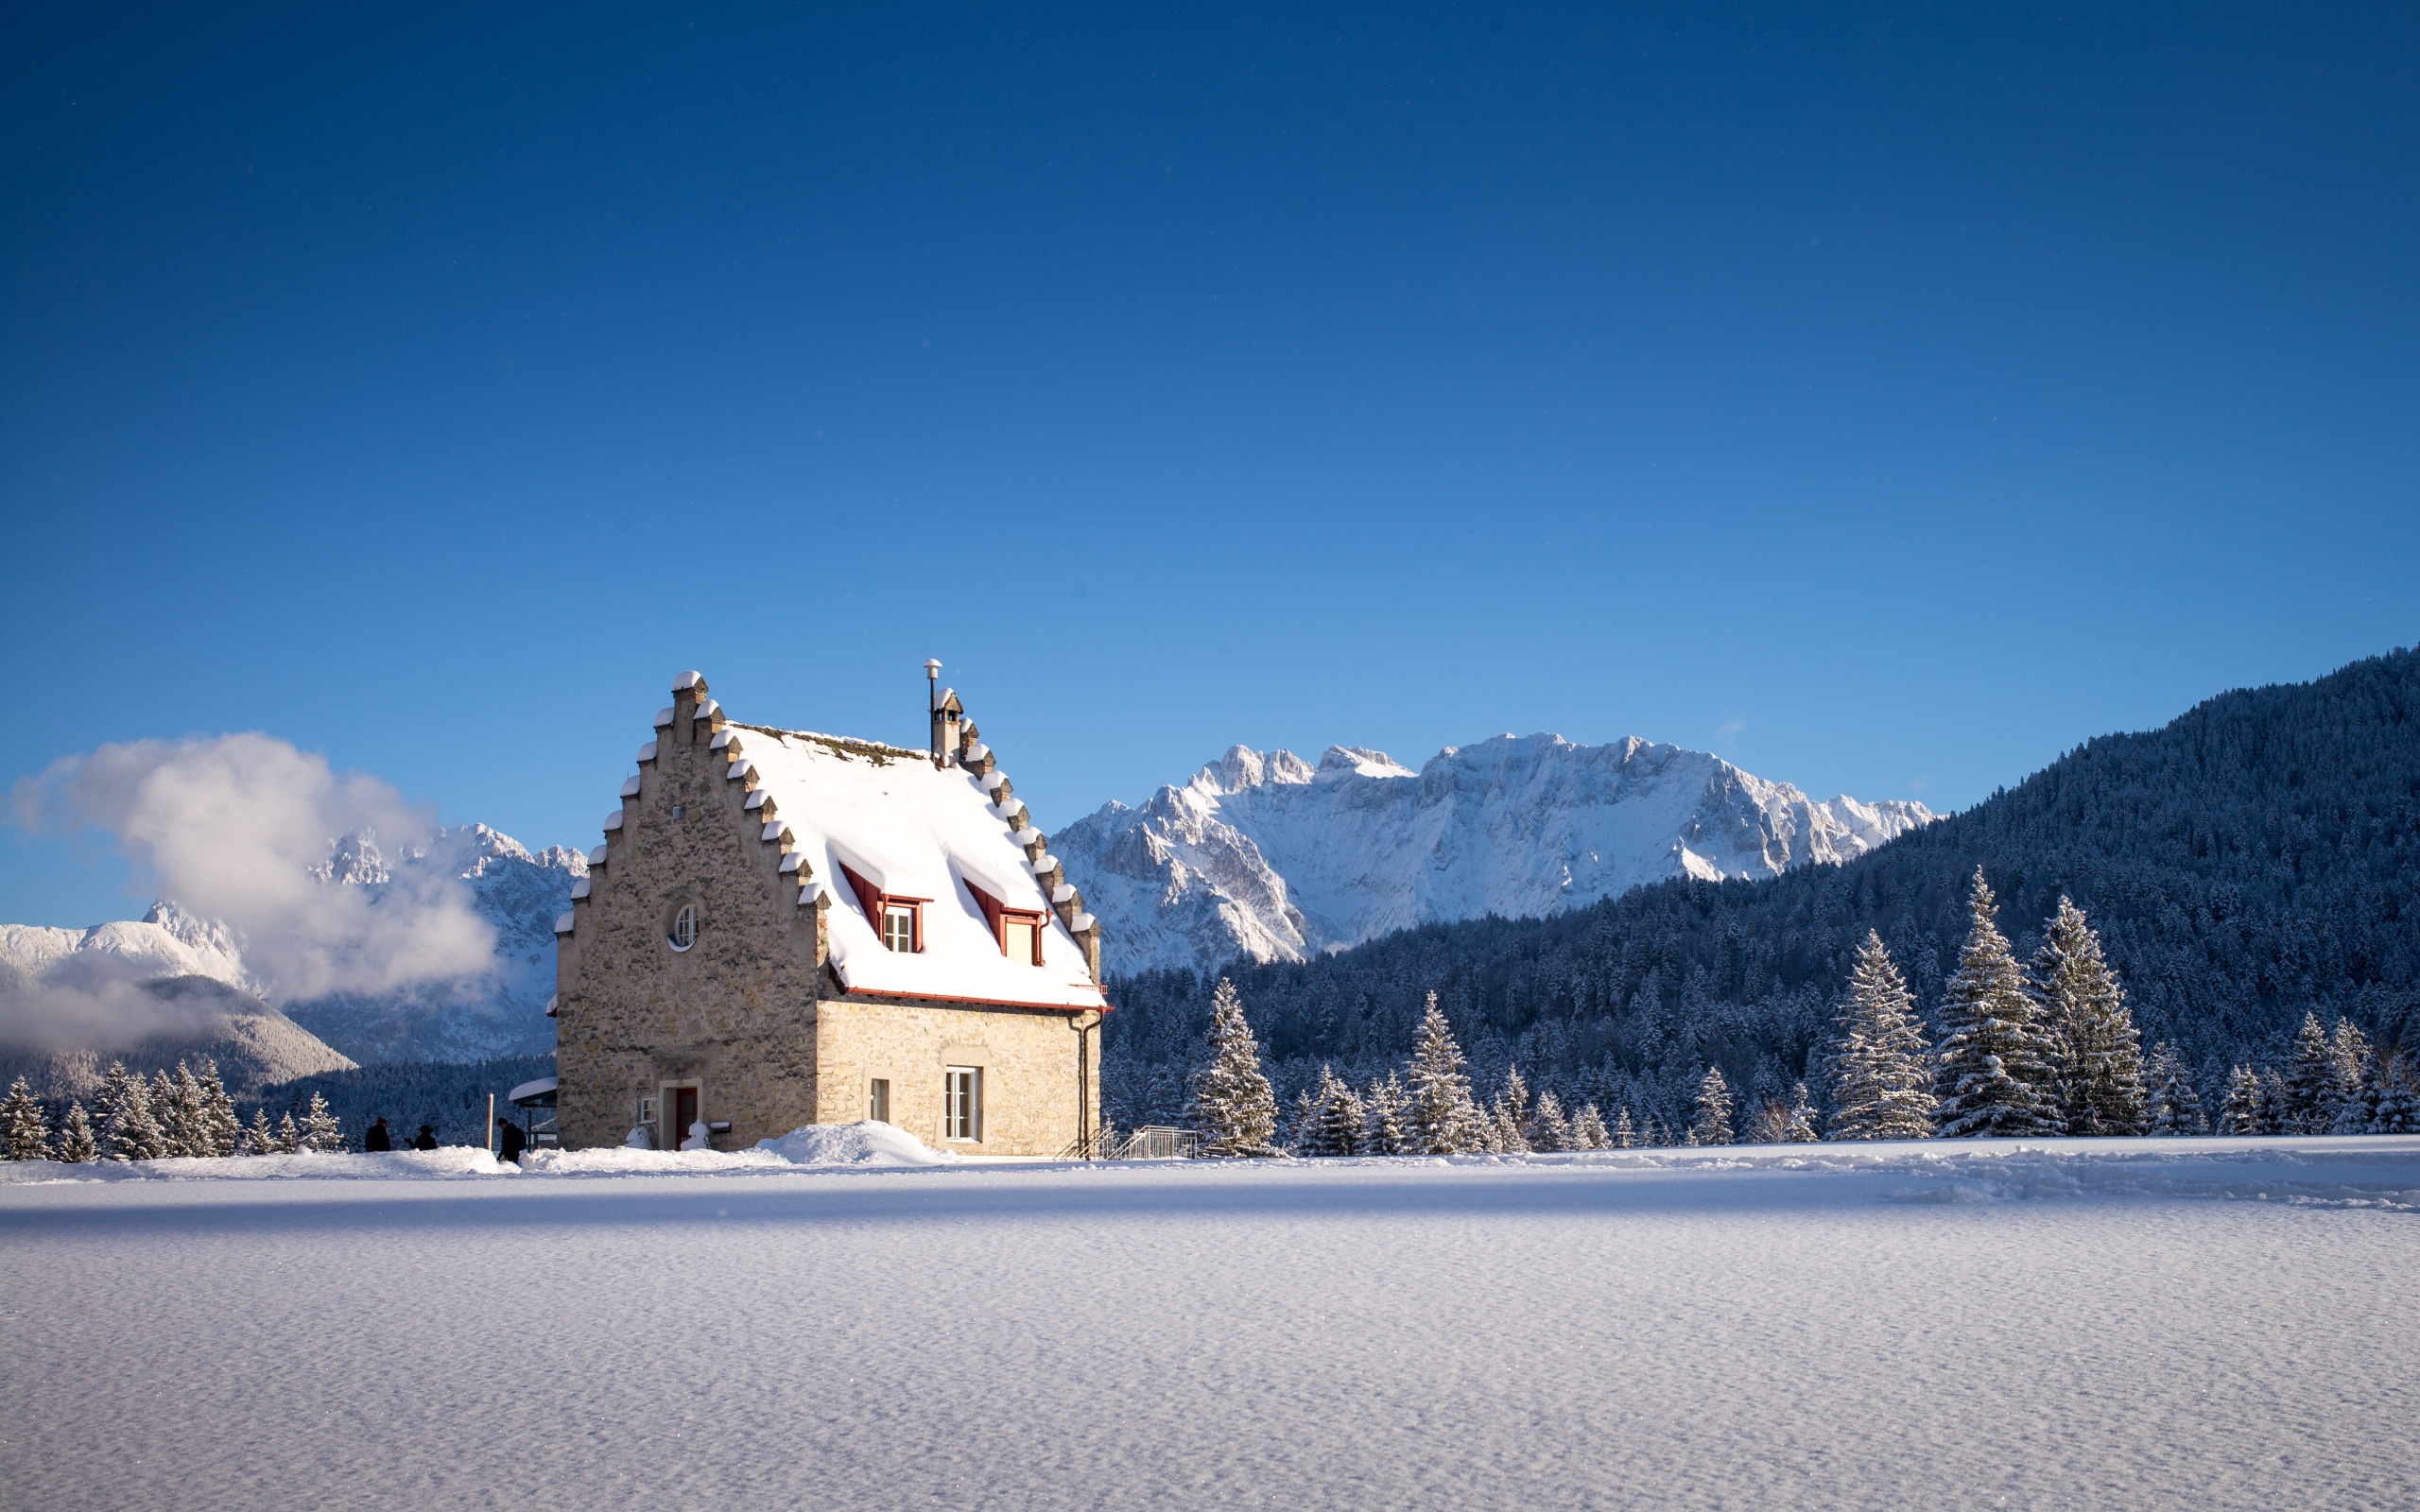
[1050,735,1933,972]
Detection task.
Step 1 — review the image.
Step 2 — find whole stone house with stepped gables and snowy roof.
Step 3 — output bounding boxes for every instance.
[554,662,1108,1157]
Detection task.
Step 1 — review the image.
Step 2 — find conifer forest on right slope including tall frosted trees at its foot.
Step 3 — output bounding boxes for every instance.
[1101,651,2420,1149]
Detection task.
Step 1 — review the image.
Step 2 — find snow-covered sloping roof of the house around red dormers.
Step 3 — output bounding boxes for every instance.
[723,726,1103,1009]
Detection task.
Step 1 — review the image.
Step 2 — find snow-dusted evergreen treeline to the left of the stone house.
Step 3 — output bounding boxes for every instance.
[0,1055,554,1163]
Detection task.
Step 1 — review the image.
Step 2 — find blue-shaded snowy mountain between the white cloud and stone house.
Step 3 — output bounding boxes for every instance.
[284,825,588,1062]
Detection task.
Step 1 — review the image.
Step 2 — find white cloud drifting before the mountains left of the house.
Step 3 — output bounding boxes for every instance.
[9,733,496,999]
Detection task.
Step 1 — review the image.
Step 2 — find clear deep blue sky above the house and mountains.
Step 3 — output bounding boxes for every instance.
[0,5,2420,924]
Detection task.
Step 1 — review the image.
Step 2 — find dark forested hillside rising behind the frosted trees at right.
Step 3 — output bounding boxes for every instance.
[1103,651,2420,1125]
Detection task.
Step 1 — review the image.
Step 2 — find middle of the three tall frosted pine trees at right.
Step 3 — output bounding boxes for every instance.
[1933,866,2060,1140]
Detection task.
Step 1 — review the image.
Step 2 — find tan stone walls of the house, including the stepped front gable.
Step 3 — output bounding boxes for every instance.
[557,682,1101,1154]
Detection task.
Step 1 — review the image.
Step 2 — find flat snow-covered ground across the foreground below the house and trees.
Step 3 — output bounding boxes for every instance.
[0,1137,2420,1512]
